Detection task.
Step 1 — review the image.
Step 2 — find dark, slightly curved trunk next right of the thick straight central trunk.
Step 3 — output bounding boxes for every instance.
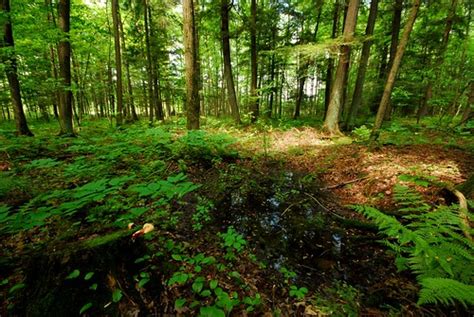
[221,0,240,124]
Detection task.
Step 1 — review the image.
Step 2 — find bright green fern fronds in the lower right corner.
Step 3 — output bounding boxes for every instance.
[354,185,474,306]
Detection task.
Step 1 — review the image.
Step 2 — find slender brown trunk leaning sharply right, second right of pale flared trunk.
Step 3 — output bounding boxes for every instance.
[370,0,421,141]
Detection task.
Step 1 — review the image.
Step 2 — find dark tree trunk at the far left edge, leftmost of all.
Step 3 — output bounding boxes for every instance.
[0,0,33,136]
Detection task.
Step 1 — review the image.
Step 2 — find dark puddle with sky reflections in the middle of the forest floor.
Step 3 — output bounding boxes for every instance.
[216,172,346,286]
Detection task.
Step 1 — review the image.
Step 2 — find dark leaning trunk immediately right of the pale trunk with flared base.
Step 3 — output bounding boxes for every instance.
[345,0,379,130]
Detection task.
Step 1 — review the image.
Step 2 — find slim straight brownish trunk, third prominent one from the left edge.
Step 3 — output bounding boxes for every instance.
[112,0,123,126]
